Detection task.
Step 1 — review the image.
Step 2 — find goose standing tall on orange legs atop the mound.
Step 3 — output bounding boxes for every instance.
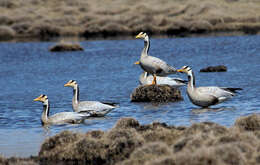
[135,32,176,84]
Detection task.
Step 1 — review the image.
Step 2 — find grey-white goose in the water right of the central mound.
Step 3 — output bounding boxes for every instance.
[177,66,242,107]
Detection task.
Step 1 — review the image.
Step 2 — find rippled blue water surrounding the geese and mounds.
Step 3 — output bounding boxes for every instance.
[0,36,260,156]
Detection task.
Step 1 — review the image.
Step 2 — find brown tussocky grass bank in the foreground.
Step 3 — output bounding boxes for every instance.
[0,114,260,165]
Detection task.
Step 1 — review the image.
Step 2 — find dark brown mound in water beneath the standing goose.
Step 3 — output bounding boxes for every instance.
[130,85,183,102]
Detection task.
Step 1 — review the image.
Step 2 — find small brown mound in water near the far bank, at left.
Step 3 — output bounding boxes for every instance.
[49,42,84,52]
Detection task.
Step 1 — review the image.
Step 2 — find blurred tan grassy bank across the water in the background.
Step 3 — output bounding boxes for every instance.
[0,0,260,40]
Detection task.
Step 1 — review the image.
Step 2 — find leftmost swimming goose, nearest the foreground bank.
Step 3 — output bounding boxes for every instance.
[34,95,90,125]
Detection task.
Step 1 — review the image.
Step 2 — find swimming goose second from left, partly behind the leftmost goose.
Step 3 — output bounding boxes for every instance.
[64,80,118,117]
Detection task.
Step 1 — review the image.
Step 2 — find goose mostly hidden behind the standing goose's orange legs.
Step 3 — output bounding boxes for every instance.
[139,72,187,88]
